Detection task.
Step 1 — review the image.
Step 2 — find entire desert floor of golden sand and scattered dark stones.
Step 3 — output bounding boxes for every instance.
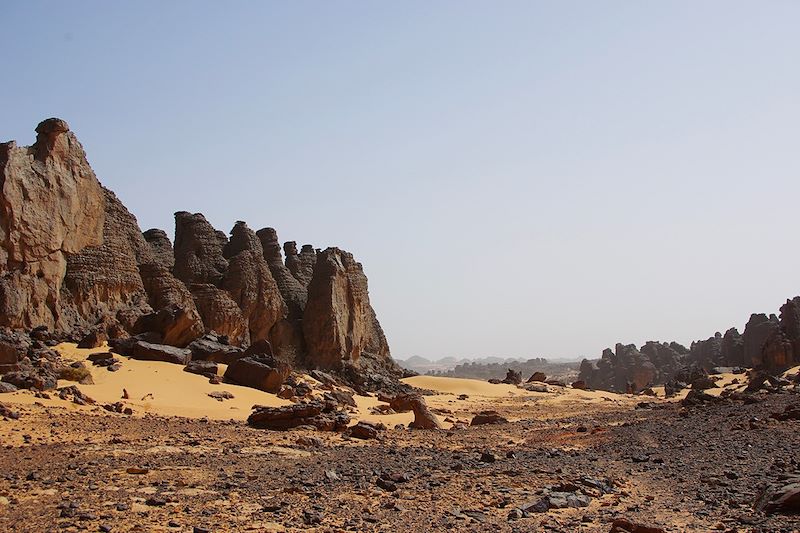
[0,345,800,532]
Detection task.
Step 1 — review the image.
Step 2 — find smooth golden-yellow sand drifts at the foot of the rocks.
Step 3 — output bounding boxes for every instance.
[3,343,626,427]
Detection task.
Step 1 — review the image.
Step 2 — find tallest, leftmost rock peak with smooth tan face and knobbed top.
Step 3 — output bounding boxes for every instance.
[0,118,105,330]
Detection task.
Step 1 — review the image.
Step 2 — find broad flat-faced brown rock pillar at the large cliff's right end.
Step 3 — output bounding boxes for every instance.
[303,248,391,369]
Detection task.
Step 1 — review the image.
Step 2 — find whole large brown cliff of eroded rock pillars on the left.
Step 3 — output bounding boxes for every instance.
[0,119,399,373]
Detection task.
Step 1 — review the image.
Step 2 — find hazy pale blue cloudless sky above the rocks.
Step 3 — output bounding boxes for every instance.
[0,0,800,359]
